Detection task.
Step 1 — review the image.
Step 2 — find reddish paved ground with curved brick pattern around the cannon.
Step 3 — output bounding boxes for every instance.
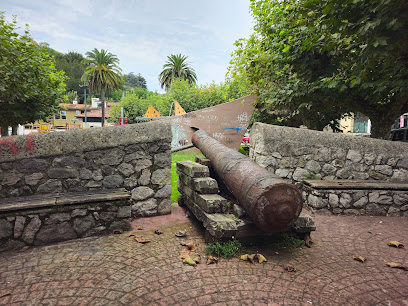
[0,204,408,305]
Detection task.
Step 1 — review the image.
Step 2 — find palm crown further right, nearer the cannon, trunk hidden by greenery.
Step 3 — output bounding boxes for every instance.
[159,54,197,90]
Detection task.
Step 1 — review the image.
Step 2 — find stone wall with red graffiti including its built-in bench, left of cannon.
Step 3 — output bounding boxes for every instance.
[0,122,171,248]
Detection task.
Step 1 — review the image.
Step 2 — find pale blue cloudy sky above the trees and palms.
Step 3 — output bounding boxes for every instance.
[0,0,252,92]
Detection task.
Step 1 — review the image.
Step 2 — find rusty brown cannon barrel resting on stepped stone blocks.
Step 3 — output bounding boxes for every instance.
[192,130,303,233]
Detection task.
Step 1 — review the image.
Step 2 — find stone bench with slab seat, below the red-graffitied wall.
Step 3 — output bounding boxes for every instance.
[0,188,131,251]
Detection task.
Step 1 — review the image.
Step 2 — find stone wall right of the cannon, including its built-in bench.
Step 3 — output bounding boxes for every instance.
[250,123,408,216]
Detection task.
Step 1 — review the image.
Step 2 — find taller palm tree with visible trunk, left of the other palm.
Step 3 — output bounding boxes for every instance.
[85,48,122,126]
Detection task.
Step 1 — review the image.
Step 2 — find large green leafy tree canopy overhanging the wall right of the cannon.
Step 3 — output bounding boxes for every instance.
[231,0,408,138]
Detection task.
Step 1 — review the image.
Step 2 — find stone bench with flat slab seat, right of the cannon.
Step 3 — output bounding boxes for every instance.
[302,180,408,217]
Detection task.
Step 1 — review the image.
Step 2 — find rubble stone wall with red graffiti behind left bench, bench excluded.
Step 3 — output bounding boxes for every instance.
[0,122,171,216]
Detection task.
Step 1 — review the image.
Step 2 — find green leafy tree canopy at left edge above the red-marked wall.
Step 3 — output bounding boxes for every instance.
[0,13,65,135]
